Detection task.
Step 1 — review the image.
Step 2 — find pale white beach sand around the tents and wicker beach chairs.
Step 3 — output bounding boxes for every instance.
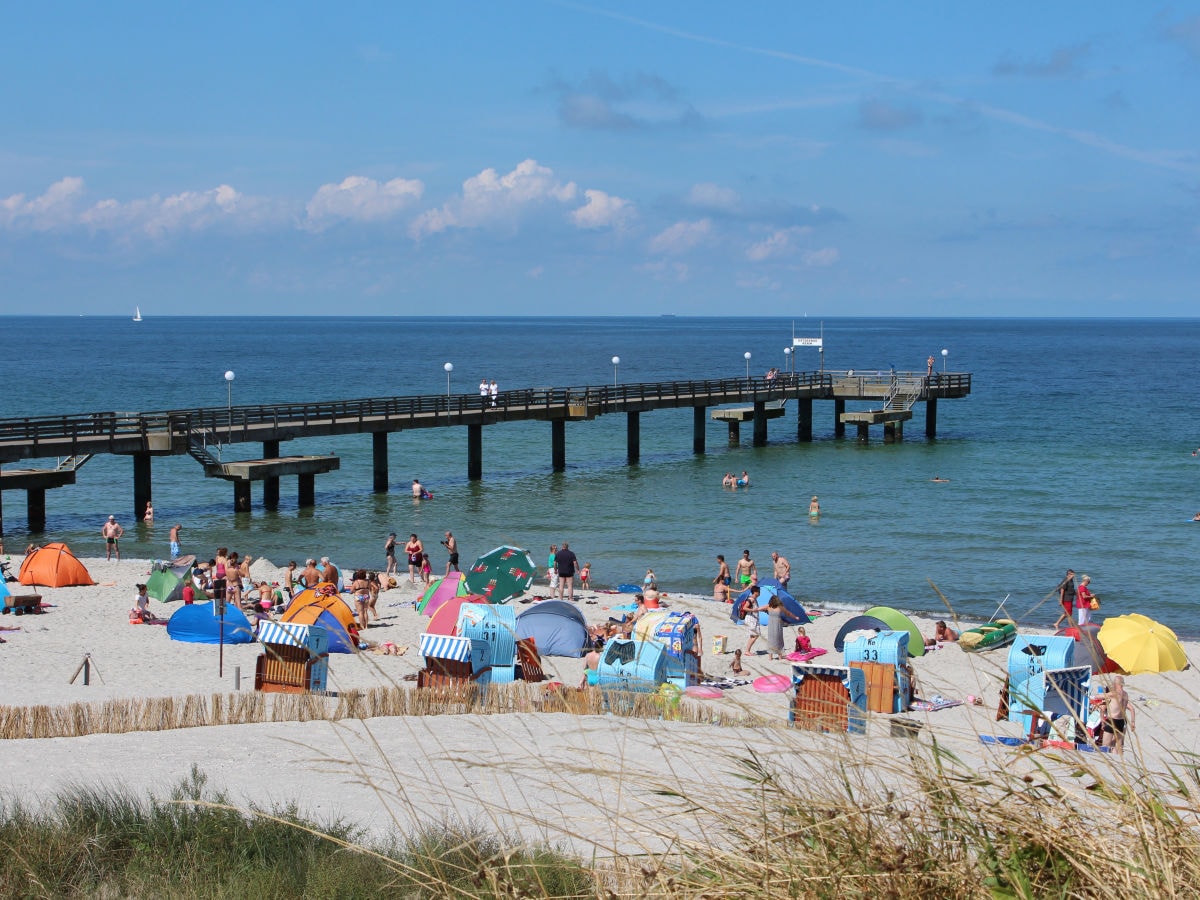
[0,559,1200,853]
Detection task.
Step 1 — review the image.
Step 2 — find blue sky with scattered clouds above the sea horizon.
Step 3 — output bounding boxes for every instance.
[0,0,1200,316]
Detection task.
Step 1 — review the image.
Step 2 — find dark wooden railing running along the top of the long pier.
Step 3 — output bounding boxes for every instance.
[0,370,971,461]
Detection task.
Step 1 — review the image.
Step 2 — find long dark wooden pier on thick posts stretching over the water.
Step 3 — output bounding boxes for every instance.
[0,370,971,533]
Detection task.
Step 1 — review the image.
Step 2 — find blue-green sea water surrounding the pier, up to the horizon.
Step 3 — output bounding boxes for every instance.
[0,311,1200,637]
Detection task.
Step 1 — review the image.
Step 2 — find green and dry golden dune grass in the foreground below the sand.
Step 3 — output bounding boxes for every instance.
[7,742,1200,900]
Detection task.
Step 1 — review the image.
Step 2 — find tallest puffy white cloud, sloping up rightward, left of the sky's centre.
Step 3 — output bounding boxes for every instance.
[410,160,576,238]
